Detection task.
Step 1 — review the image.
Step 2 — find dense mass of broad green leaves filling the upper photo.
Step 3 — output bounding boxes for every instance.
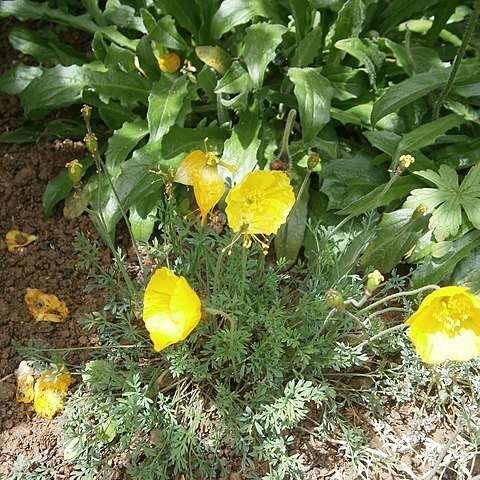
[0,0,480,284]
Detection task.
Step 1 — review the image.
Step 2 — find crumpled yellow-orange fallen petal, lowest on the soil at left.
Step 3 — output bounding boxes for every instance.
[33,366,72,420]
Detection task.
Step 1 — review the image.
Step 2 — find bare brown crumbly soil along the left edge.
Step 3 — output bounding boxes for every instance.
[0,20,108,476]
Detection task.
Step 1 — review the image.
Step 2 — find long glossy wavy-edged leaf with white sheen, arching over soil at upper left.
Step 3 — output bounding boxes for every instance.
[20,65,150,119]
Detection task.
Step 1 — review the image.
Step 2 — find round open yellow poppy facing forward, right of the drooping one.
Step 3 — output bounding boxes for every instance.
[225,170,295,252]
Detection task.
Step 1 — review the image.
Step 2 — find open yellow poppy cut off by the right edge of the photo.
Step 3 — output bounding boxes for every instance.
[405,287,480,363]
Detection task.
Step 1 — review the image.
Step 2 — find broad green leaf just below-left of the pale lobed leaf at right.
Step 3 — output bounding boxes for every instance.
[360,208,428,272]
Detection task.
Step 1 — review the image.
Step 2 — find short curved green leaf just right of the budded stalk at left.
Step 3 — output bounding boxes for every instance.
[105,118,148,178]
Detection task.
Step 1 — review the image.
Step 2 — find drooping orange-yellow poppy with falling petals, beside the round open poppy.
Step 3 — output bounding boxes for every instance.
[174,146,236,225]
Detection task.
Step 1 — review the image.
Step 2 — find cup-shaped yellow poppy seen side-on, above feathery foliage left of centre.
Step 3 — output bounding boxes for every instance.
[143,267,202,352]
